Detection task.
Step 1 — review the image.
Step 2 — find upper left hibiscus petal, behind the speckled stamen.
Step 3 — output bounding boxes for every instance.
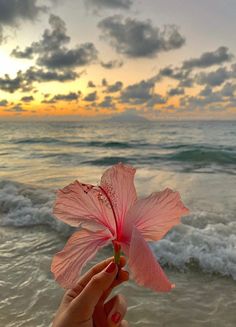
[53,180,115,231]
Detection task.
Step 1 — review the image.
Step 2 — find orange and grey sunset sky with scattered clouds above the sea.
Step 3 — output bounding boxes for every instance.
[0,0,236,121]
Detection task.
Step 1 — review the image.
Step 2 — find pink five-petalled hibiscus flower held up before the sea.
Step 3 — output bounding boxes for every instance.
[51,163,188,292]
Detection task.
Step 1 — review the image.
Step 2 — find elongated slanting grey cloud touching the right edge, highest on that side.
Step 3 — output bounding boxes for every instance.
[182,46,233,69]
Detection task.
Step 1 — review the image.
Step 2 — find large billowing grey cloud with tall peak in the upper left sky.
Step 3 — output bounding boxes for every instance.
[12,15,98,71]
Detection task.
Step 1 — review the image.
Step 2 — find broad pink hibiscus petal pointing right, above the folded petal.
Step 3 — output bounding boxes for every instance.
[123,188,189,241]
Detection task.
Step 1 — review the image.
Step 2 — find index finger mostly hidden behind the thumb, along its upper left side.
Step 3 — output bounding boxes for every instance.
[73,256,126,294]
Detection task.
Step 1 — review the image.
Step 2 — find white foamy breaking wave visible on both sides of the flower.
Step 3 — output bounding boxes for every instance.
[0,180,236,280]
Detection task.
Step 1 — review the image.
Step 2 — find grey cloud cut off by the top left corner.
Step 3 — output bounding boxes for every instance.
[0,0,47,25]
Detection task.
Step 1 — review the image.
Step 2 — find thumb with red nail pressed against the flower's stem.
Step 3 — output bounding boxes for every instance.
[71,262,118,319]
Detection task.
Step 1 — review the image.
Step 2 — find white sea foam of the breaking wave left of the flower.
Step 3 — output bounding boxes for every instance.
[0,181,71,235]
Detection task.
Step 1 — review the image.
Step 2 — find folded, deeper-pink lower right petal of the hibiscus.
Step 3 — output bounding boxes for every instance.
[126,227,174,292]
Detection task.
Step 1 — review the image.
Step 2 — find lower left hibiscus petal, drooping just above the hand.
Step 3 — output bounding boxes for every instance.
[51,230,112,288]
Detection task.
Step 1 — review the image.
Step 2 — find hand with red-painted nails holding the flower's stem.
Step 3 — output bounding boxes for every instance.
[52,257,129,327]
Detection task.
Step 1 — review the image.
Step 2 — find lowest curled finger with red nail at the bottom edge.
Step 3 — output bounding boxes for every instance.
[104,294,127,327]
